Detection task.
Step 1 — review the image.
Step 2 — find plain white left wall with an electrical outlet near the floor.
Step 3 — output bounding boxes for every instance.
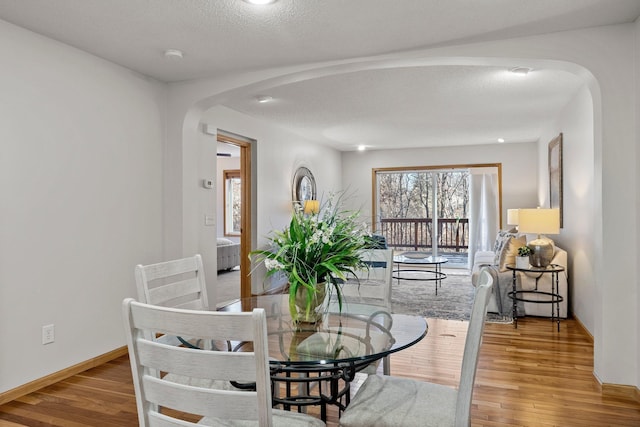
[0,21,166,392]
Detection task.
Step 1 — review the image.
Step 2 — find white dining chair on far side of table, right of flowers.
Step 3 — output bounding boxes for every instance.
[329,249,393,375]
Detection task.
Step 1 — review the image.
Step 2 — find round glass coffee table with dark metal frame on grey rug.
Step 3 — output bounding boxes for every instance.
[393,252,447,295]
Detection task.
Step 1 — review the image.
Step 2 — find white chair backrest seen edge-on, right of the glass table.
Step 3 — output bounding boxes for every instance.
[455,267,493,427]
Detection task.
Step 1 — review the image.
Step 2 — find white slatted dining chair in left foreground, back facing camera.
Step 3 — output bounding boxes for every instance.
[122,298,325,427]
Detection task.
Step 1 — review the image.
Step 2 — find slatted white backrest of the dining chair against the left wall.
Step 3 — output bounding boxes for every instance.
[135,255,209,310]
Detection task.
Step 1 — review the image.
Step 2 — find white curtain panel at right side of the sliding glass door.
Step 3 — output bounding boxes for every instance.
[469,168,500,269]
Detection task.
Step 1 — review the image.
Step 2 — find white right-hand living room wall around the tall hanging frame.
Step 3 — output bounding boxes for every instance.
[539,87,598,334]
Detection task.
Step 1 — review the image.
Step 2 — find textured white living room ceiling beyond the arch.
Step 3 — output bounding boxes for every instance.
[226,66,581,150]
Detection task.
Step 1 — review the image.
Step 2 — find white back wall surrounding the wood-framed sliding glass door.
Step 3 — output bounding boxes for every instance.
[342,142,538,228]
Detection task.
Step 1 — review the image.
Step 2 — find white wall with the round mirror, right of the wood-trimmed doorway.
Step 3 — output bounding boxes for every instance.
[202,106,342,293]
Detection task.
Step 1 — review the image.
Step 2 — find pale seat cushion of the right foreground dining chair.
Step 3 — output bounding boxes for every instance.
[340,375,458,427]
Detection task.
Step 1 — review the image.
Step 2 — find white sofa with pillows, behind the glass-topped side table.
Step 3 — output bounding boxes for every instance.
[471,230,569,318]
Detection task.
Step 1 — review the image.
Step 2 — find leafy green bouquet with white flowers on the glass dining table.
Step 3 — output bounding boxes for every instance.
[250,197,373,320]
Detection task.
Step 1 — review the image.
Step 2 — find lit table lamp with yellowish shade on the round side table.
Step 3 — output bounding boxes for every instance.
[518,208,560,267]
